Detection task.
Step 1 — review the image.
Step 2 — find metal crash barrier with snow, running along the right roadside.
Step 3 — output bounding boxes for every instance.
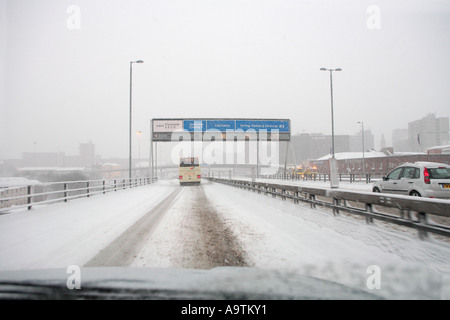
[208,178,450,239]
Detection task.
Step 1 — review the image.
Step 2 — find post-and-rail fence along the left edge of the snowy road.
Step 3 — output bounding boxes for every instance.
[0,177,157,213]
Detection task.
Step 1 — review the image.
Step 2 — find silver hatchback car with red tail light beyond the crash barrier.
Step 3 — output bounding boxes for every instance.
[372,162,450,199]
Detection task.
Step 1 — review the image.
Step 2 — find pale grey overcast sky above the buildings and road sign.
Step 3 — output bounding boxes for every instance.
[0,0,450,159]
